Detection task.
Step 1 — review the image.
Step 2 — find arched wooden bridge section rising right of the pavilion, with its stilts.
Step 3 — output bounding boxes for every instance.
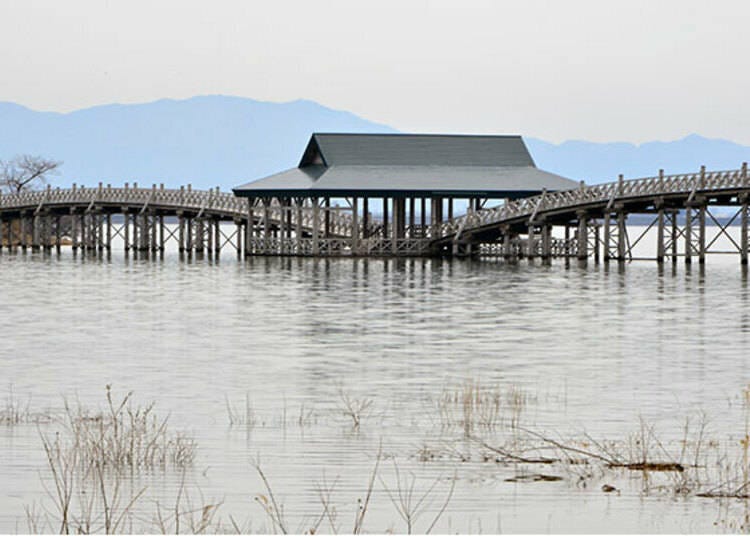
[433,163,750,264]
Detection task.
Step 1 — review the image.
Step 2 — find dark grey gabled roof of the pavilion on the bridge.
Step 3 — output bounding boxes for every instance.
[234,134,577,197]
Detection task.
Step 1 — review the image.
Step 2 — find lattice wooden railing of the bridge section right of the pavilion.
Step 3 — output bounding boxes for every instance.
[435,167,750,239]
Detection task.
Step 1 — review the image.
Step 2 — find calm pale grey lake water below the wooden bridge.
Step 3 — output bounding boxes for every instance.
[0,225,750,532]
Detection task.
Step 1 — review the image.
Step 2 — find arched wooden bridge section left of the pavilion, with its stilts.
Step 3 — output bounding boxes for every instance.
[0,183,352,254]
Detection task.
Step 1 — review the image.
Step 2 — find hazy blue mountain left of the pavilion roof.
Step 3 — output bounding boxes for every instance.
[0,96,395,189]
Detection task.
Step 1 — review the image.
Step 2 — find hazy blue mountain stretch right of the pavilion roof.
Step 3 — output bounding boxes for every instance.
[526,134,750,183]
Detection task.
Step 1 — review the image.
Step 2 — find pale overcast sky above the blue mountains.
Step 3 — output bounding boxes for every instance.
[0,0,750,144]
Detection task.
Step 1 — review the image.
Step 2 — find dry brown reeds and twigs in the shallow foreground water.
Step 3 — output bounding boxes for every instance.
[0,386,750,534]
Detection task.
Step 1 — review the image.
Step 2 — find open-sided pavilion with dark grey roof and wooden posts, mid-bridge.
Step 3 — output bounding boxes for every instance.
[234,134,577,255]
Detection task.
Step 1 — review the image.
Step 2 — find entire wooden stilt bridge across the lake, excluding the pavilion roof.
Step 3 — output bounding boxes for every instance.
[0,164,750,264]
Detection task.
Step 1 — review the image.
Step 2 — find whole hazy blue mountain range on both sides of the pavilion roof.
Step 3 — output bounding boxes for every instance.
[0,96,750,190]
